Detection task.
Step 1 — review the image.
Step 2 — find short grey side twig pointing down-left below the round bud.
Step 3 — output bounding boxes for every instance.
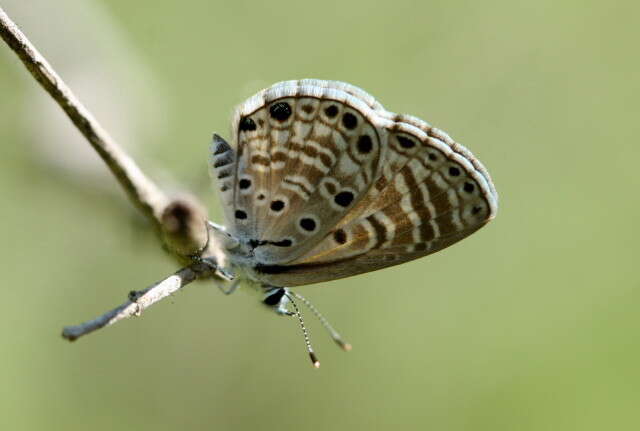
[62,265,211,341]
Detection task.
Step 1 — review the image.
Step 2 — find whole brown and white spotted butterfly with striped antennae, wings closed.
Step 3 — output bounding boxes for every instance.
[210,79,498,367]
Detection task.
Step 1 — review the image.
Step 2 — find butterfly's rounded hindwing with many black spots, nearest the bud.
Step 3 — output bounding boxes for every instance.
[212,80,396,265]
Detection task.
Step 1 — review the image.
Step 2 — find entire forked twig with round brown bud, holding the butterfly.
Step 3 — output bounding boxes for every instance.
[0,8,224,341]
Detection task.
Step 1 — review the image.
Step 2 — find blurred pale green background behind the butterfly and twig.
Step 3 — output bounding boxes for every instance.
[0,0,640,431]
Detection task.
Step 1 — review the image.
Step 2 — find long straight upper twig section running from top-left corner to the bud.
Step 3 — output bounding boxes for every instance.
[0,8,169,228]
